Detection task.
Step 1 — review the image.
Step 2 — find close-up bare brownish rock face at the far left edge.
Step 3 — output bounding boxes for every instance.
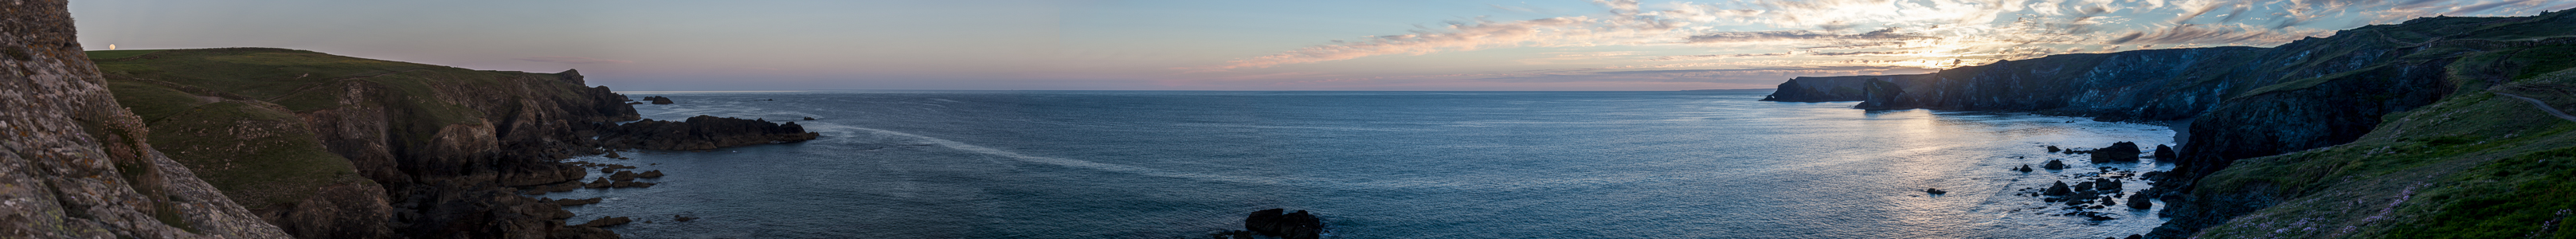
[0,0,286,239]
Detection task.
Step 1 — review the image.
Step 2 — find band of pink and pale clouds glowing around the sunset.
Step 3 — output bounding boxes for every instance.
[1190,0,2571,72]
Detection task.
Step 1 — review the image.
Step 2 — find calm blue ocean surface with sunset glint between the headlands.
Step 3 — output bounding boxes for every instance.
[541,90,2174,239]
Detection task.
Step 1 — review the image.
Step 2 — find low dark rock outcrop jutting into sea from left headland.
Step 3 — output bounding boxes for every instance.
[601,116,822,149]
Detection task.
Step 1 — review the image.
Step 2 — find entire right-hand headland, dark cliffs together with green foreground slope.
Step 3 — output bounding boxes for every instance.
[1813,13,2576,239]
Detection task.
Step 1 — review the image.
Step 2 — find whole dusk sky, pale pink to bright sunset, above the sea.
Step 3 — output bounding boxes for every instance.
[72,0,2576,90]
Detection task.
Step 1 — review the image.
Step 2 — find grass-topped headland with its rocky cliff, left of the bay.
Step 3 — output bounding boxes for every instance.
[88,49,636,239]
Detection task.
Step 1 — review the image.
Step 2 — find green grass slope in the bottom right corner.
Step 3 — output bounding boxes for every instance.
[2194,92,2576,239]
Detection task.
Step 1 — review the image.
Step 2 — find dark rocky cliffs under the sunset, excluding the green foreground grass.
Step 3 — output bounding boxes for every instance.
[1803,13,2576,237]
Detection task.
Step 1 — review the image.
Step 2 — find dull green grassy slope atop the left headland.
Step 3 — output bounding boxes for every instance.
[90,49,505,208]
